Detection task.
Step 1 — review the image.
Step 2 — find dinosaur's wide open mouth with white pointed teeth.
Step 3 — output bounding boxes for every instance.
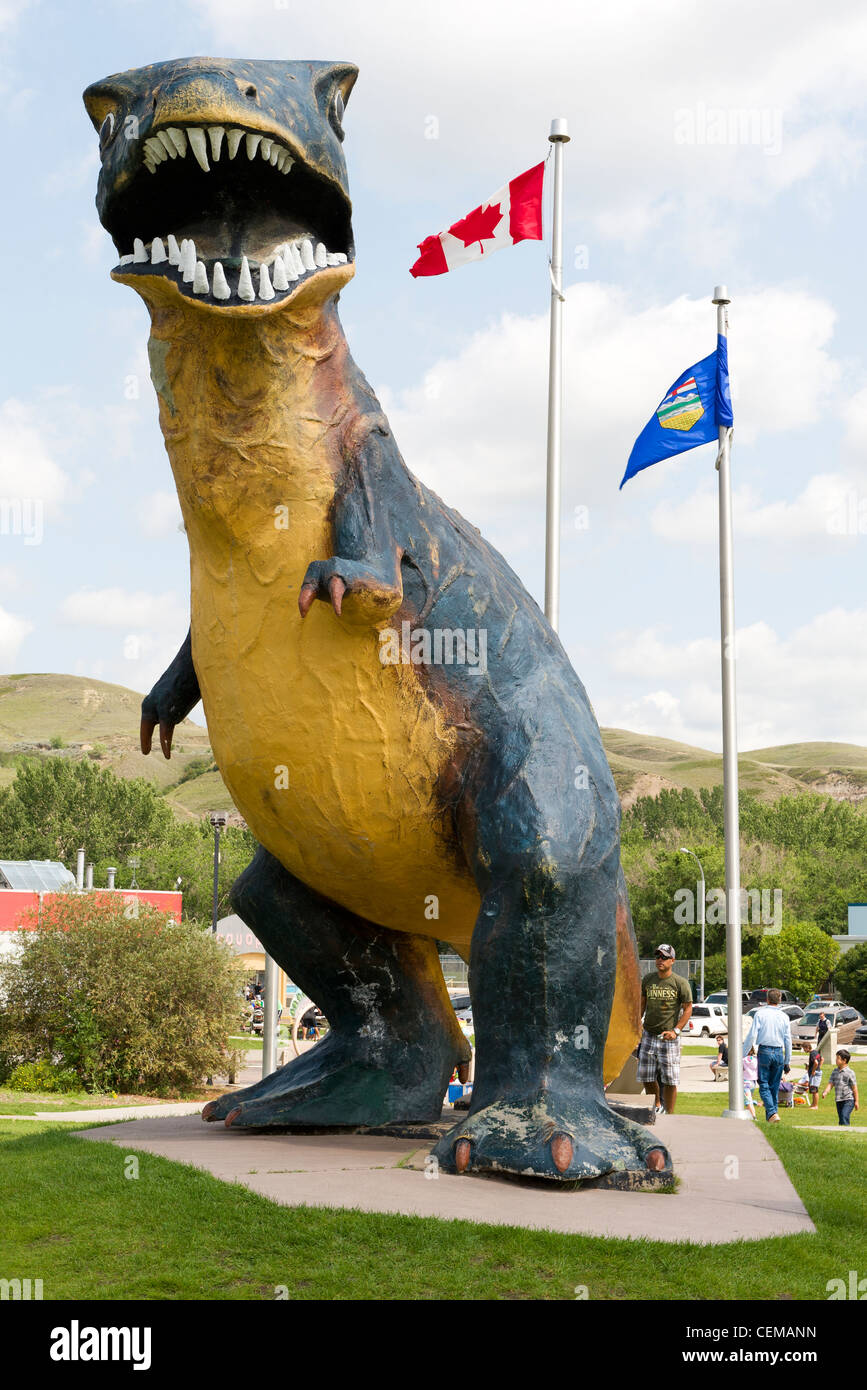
[104,125,353,307]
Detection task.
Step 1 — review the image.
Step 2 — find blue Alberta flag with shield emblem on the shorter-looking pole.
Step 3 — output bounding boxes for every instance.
[620,335,732,488]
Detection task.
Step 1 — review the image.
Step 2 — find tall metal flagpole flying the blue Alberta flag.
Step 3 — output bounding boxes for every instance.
[713,285,749,1120]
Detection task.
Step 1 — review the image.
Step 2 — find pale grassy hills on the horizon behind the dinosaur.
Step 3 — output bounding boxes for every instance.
[0,674,867,819]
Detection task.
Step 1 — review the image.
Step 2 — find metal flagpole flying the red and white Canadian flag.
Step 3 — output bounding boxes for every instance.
[545,115,571,632]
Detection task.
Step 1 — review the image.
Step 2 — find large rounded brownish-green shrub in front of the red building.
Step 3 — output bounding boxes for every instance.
[0,894,240,1095]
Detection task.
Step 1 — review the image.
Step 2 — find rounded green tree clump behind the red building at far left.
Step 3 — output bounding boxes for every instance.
[0,758,175,863]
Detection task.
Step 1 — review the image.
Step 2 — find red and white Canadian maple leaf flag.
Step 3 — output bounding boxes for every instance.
[410,161,545,275]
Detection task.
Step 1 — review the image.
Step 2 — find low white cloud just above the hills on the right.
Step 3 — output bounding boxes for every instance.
[593,607,867,751]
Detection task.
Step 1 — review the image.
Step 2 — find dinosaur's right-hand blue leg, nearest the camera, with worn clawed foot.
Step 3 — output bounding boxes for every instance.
[434,739,671,1186]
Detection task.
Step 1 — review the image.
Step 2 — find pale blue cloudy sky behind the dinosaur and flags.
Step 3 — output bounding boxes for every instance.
[0,0,867,749]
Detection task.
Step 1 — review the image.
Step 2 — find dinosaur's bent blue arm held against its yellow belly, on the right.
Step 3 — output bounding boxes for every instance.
[299,424,403,623]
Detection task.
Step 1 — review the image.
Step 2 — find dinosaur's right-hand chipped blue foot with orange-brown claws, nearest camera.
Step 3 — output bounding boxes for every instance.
[434,1093,672,1187]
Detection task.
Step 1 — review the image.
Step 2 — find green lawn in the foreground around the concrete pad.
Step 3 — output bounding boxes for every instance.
[0,1097,867,1302]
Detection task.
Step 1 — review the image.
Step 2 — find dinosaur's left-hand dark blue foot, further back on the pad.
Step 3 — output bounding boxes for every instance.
[201,1031,459,1129]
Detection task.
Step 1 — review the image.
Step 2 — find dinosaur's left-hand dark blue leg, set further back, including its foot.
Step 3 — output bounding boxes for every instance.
[203,849,470,1129]
